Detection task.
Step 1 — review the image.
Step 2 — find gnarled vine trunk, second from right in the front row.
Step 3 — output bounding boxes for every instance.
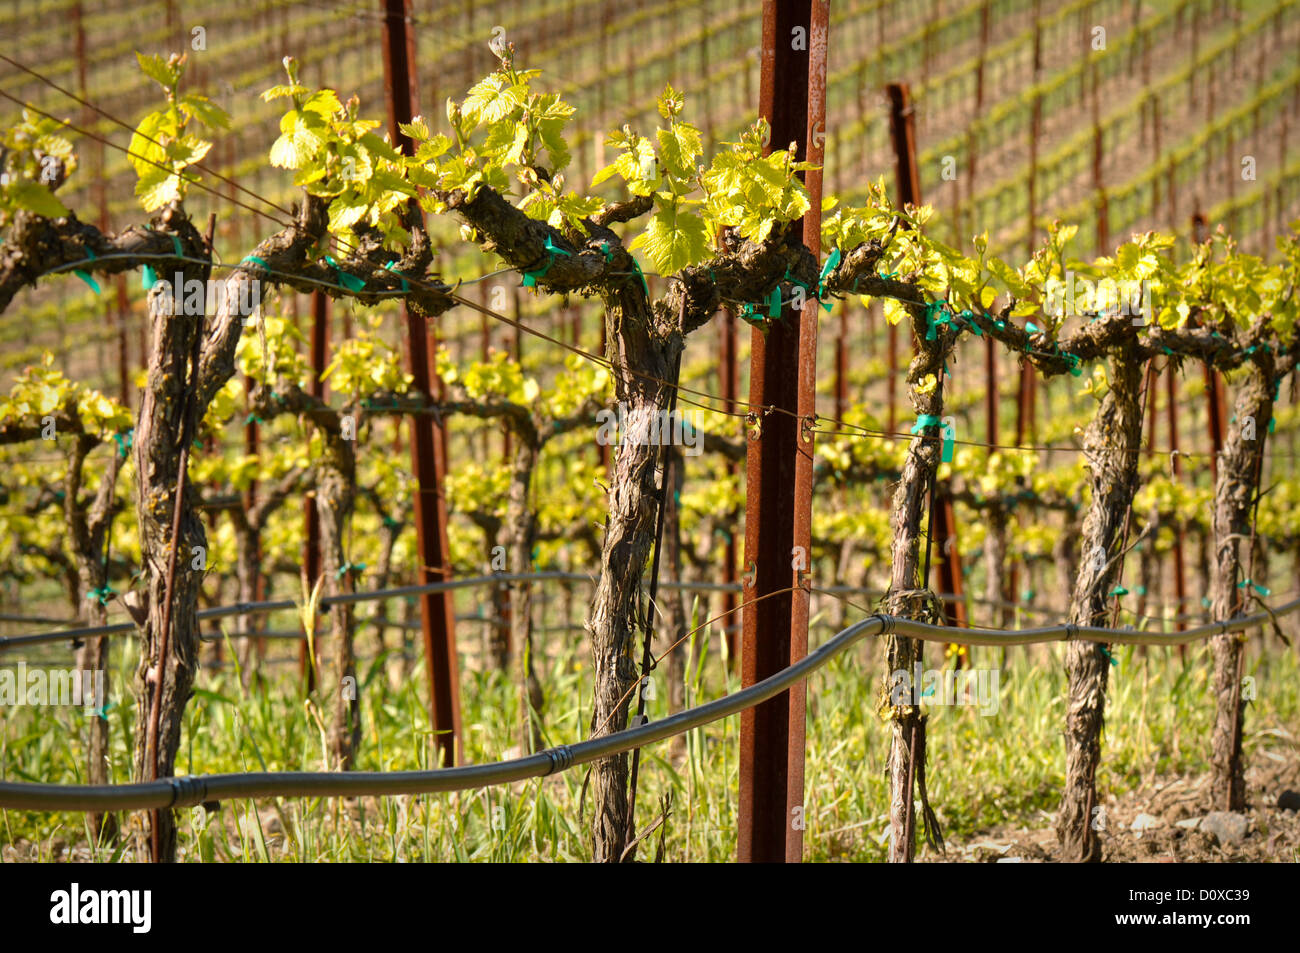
[1056,354,1143,862]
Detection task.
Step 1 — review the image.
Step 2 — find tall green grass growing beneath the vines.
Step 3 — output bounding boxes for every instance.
[0,590,1300,862]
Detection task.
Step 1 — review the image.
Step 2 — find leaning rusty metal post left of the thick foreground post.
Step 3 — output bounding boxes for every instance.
[384,0,462,766]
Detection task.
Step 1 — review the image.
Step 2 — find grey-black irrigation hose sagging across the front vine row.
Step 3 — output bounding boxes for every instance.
[0,598,1300,811]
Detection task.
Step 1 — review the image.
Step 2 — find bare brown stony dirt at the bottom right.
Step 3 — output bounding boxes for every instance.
[924,761,1300,863]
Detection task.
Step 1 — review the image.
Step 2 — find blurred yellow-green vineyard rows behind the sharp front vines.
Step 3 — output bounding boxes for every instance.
[0,0,1300,859]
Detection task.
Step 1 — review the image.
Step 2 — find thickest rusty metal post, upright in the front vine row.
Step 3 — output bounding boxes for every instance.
[737,0,811,863]
